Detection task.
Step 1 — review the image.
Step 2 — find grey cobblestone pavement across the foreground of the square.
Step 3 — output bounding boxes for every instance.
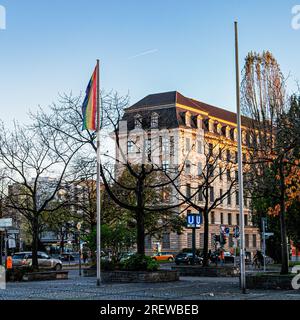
[0,270,300,300]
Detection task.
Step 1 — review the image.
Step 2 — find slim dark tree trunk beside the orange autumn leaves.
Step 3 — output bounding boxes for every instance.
[279,163,289,274]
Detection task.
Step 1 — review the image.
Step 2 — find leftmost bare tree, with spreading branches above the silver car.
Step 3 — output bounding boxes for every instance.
[0,123,80,269]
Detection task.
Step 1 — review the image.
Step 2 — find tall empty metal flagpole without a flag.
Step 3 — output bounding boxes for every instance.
[234,21,246,293]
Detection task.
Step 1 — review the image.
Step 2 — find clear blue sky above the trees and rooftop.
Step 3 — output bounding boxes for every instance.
[0,0,300,125]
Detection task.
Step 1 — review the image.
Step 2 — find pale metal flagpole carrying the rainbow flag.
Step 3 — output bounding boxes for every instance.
[97,59,101,286]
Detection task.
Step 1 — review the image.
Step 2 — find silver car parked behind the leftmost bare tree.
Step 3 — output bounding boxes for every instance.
[12,251,62,271]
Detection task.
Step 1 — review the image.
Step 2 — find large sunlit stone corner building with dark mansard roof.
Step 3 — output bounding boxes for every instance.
[116,91,261,254]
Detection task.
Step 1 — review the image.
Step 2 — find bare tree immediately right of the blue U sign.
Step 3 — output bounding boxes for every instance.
[163,138,238,266]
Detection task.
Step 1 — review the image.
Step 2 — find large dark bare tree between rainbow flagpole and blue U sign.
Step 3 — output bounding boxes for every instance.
[34,93,188,254]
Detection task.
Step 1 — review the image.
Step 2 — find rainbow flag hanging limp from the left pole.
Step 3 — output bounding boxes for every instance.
[82,66,98,131]
